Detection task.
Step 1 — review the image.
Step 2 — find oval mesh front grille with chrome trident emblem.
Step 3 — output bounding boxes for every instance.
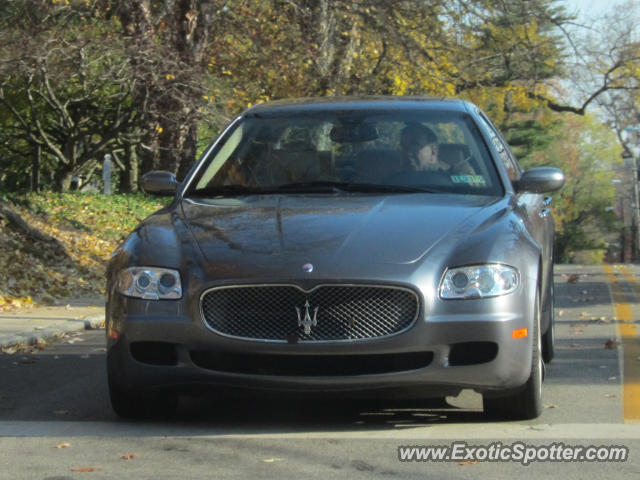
[201,285,418,343]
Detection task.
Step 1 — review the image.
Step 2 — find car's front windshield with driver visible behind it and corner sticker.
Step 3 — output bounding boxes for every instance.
[187,111,503,196]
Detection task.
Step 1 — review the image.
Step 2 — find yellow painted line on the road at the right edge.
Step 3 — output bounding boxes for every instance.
[603,265,640,423]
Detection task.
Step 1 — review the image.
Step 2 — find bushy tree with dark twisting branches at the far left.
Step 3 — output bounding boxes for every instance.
[0,1,136,190]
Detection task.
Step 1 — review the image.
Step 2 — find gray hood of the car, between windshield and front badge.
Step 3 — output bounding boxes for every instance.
[182,194,496,264]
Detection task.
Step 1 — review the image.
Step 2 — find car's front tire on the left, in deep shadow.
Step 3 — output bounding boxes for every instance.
[109,378,178,420]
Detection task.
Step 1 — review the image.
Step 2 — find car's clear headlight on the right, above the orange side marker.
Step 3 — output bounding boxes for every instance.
[439,263,520,299]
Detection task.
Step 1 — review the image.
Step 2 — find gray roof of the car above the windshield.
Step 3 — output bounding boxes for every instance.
[244,96,469,116]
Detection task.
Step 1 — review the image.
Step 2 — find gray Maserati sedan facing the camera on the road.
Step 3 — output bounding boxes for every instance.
[106,97,564,419]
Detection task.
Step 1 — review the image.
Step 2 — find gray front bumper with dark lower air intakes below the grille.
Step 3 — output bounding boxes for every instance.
[107,289,533,397]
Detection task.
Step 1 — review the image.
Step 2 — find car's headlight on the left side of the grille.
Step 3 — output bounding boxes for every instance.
[118,267,182,300]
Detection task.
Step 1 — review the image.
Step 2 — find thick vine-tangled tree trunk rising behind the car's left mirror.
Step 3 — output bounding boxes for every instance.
[113,0,223,177]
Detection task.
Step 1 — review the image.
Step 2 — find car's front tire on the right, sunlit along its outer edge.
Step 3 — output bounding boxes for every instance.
[482,295,544,420]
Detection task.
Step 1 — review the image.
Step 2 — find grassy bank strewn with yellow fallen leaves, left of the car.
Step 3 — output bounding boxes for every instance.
[0,192,169,309]
